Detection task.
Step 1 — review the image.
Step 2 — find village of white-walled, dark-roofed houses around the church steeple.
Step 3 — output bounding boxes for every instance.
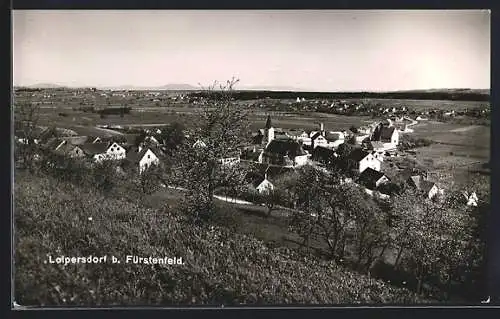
[15,109,478,210]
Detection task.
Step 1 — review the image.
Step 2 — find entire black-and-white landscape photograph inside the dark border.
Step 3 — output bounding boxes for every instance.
[11,10,491,309]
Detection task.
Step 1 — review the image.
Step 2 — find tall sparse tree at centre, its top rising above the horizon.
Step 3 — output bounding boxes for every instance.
[174,78,248,220]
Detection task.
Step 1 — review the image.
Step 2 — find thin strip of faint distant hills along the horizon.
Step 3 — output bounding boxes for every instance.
[15,83,490,95]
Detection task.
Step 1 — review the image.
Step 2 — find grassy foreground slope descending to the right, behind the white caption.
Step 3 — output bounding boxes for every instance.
[15,174,419,306]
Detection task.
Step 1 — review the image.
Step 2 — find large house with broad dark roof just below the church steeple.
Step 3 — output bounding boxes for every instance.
[262,139,309,166]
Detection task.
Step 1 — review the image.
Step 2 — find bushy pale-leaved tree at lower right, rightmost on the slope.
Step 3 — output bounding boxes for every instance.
[393,189,471,294]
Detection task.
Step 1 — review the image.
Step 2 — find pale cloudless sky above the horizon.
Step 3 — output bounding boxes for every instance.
[12,10,490,92]
